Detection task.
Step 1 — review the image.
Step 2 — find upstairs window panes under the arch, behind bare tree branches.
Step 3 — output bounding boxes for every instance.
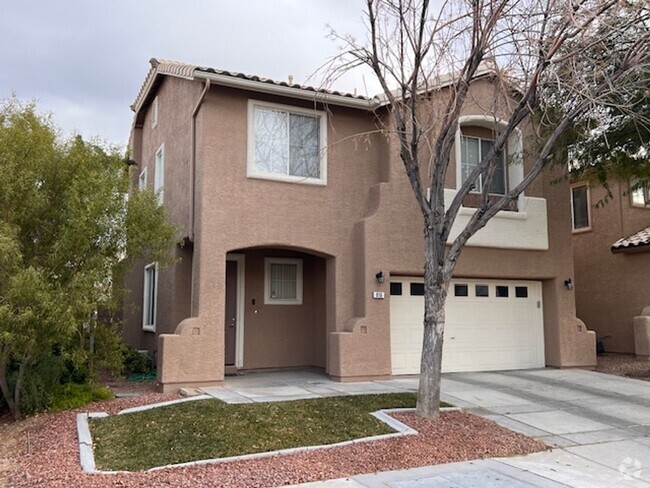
[460,135,507,195]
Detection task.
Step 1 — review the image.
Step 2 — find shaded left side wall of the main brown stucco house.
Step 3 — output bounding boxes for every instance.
[123,77,201,351]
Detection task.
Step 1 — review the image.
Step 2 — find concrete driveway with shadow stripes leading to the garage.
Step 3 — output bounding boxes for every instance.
[438,369,650,488]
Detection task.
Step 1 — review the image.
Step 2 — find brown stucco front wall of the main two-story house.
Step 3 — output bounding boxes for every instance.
[147,76,595,384]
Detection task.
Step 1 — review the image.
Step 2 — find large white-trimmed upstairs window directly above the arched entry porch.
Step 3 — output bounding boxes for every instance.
[248,100,327,185]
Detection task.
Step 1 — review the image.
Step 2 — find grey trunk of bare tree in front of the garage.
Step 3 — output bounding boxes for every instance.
[416,225,447,418]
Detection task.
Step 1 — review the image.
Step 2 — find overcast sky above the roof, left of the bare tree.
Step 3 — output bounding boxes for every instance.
[0,0,374,148]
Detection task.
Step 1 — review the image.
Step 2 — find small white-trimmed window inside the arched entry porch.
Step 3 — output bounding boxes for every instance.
[264,258,302,305]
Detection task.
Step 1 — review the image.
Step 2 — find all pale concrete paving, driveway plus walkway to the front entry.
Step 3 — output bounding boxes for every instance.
[205,369,650,488]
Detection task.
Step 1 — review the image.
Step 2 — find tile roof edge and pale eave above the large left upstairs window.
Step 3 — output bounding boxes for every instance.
[131,58,371,111]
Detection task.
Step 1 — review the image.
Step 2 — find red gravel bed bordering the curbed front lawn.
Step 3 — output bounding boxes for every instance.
[0,394,546,488]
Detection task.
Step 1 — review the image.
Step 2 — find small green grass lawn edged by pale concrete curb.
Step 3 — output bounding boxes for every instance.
[90,393,440,471]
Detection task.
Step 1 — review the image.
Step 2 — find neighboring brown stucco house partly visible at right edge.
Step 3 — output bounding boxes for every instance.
[571,177,650,353]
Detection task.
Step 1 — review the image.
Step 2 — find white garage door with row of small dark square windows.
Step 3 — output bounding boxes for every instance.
[390,276,545,374]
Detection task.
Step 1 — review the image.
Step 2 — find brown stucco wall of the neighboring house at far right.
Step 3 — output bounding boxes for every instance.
[569,181,650,353]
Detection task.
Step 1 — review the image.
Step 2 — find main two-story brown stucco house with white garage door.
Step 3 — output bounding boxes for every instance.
[124,59,595,390]
